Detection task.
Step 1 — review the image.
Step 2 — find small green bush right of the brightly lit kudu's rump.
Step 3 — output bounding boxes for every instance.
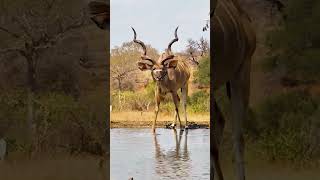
[194,56,210,85]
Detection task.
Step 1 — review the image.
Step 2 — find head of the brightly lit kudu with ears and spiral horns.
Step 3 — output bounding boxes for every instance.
[132,27,178,81]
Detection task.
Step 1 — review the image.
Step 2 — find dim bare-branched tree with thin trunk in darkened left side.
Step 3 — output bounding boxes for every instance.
[0,0,88,142]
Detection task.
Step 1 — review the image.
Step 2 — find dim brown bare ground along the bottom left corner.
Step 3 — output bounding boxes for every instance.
[0,155,109,180]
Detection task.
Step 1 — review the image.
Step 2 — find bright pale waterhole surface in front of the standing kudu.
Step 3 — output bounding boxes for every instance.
[110,128,210,180]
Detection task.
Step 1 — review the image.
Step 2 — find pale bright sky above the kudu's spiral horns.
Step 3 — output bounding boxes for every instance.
[110,0,210,52]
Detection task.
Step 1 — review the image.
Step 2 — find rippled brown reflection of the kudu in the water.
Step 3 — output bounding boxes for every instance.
[154,129,191,179]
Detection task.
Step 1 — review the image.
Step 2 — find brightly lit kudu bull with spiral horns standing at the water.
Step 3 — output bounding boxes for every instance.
[132,27,190,132]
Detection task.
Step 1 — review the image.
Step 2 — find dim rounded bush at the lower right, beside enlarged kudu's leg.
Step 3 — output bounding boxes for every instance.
[249,91,320,161]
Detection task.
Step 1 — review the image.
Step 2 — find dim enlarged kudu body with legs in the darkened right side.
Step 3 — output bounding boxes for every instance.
[210,0,256,180]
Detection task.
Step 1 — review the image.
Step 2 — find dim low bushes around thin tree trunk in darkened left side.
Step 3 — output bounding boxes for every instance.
[0,91,106,153]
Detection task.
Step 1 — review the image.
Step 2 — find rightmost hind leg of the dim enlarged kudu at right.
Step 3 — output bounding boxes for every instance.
[230,60,250,180]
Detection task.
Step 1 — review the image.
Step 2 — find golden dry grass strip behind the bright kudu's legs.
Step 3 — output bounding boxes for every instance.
[111,111,210,128]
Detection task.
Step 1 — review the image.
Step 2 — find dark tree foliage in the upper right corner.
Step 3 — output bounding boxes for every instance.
[265,0,320,84]
